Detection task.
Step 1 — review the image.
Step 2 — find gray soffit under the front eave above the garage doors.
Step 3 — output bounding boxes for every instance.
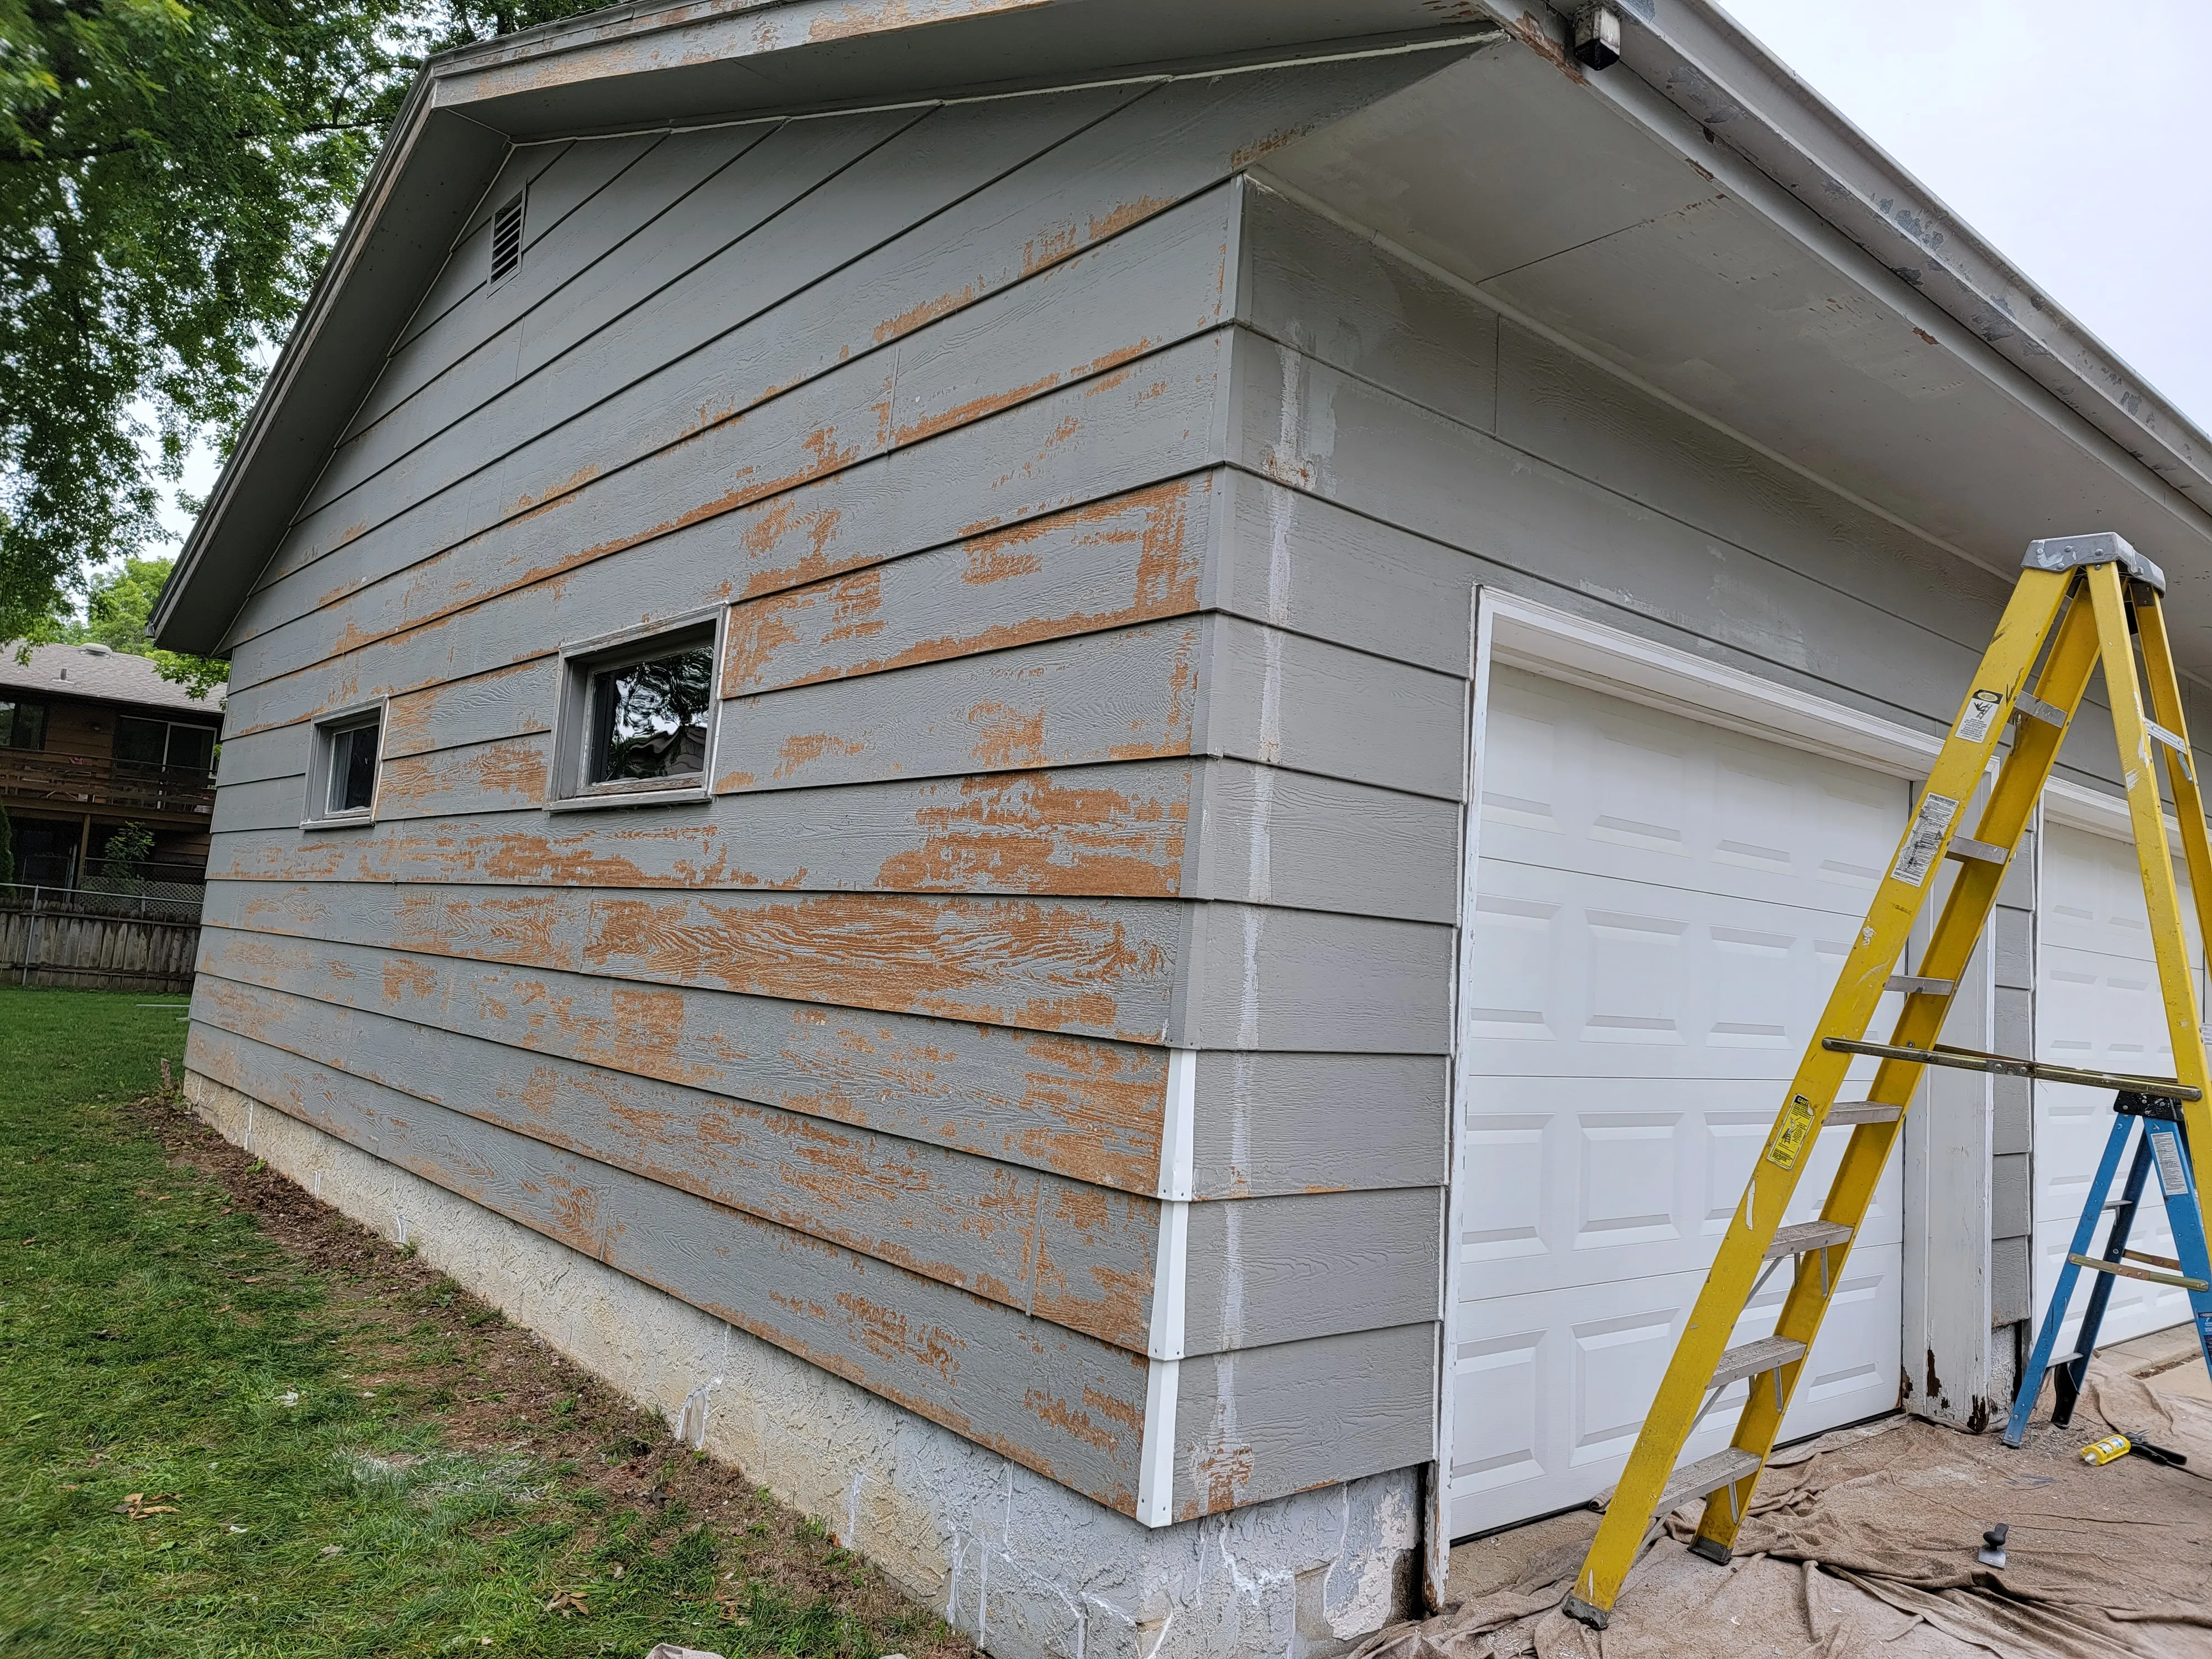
[1267,44,2212,677]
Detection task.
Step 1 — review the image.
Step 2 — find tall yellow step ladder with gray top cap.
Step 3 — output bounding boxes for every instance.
[1566,533,2212,1630]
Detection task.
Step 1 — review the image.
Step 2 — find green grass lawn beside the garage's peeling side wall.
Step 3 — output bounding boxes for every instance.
[0,987,964,1659]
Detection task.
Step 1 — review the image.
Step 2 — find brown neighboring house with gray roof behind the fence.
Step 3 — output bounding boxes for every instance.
[0,644,223,889]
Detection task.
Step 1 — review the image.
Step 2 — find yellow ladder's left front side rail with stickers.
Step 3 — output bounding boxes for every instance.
[1573,571,2075,1617]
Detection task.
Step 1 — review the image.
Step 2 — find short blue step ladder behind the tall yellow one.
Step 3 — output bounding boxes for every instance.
[2004,1091,2212,1447]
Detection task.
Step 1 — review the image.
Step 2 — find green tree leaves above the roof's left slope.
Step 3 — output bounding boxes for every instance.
[0,0,611,650]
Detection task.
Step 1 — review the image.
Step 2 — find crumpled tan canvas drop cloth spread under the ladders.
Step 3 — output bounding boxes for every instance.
[1356,1365,2212,1659]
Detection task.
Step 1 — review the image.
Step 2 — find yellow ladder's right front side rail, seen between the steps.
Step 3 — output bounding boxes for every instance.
[1692,595,2097,1559]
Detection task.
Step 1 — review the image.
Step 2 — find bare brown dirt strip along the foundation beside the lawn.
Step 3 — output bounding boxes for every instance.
[133,1099,975,1659]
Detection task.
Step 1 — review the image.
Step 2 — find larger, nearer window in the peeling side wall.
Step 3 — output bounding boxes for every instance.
[562,622,717,799]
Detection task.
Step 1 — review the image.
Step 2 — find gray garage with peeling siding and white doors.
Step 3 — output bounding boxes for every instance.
[157,0,2212,1659]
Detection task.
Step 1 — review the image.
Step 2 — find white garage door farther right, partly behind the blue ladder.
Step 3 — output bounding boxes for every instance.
[2033,823,2203,1354]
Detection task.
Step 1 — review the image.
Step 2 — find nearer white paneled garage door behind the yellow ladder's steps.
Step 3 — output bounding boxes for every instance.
[1451,670,1907,1537]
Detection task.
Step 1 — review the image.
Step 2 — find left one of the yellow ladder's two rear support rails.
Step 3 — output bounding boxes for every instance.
[2086,564,2212,1186]
